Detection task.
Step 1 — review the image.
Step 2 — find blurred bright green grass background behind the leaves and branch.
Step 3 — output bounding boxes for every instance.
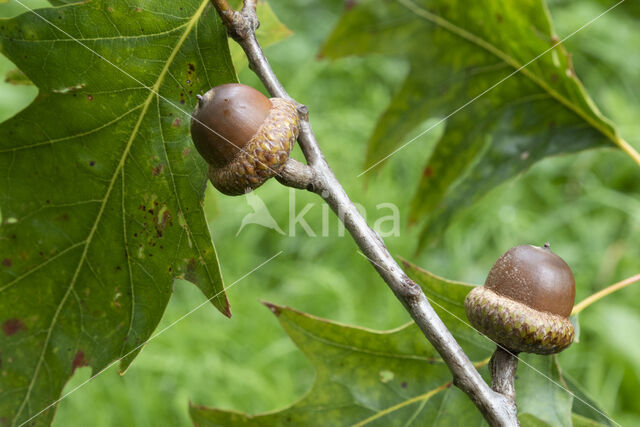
[0,0,640,426]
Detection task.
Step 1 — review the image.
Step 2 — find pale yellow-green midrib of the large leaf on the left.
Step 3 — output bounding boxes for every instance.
[12,0,209,426]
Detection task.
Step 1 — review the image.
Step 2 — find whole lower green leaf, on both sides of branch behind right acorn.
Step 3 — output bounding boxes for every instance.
[190,262,572,427]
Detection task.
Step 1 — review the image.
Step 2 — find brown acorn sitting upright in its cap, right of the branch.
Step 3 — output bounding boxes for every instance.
[464,243,576,354]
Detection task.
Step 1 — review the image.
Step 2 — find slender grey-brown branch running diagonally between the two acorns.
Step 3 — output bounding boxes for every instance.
[212,0,518,426]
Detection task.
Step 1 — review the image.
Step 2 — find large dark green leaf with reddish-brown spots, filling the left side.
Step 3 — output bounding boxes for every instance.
[0,0,235,425]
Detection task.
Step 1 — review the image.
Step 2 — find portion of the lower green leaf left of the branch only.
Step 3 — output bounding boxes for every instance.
[190,304,482,426]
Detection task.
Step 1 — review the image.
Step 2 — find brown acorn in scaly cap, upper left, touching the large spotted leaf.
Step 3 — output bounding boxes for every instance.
[191,83,298,196]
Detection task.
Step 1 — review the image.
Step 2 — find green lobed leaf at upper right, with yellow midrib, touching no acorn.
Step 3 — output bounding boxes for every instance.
[322,0,640,246]
